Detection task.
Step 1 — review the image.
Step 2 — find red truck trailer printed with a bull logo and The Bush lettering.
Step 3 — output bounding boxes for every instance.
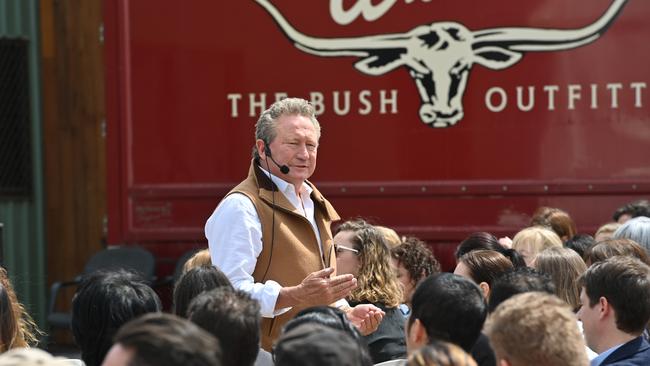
[104,0,650,268]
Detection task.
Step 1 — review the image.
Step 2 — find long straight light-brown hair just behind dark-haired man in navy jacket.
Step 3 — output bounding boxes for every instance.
[535,247,587,312]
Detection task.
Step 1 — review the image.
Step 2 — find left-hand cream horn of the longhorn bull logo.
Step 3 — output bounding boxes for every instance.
[255,0,408,57]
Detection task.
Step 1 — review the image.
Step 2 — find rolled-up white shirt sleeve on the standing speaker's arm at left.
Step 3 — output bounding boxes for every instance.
[205,193,291,318]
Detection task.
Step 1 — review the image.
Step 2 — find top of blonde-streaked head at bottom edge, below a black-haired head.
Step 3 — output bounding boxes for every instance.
[407,341,476,366]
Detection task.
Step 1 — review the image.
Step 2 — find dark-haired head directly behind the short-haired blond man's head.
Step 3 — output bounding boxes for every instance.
[488,267,555,313]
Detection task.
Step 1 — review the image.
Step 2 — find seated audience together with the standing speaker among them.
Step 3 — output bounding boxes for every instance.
[0,98,650,366]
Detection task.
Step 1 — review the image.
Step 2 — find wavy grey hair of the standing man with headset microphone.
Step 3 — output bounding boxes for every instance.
[253,98,320,159]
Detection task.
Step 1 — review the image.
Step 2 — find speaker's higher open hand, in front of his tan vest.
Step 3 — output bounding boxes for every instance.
[275,267,357,309]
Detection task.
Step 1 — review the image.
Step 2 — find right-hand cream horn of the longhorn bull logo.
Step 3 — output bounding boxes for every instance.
[472,0,627,52]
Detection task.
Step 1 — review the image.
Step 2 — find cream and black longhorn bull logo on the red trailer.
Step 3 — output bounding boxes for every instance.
[255,0,627,127]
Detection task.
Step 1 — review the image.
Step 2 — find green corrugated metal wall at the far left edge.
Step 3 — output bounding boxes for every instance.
[0,0,47,327]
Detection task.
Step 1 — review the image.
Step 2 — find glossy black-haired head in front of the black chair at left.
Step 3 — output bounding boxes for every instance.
[71,269,162,366]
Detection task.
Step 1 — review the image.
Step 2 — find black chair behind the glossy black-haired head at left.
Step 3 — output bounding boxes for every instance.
[47,246,156,330]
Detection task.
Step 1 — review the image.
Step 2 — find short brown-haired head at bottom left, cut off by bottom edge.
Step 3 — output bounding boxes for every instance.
[102,313,221,366]
